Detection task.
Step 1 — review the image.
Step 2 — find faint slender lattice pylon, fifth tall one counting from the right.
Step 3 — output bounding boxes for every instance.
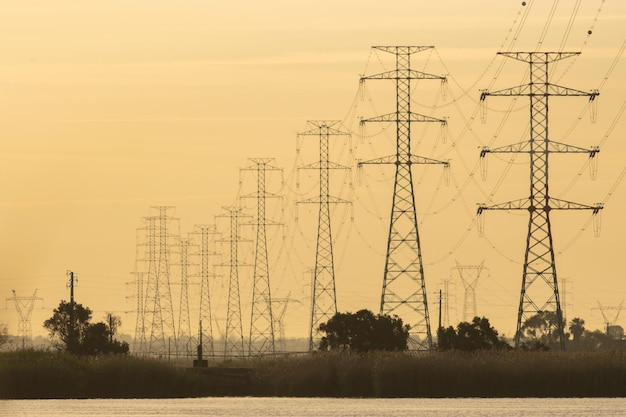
[223,206,247,358]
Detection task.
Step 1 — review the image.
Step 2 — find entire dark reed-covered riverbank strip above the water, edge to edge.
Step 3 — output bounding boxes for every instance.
[0,351,626,398]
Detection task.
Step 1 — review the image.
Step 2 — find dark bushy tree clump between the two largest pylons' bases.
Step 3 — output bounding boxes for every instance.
[437,317,510,352]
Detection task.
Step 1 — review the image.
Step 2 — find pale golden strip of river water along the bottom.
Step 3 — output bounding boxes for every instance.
[0,397,626,417]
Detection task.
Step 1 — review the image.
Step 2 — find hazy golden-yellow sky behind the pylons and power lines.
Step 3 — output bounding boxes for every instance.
[0,0,626,342]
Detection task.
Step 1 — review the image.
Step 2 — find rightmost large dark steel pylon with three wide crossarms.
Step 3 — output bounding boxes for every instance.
[478,52,602,349]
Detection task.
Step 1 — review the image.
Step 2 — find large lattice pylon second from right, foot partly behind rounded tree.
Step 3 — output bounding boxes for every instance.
[358,46,448,350]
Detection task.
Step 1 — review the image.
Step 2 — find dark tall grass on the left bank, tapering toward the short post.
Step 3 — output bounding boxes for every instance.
[0,350,205,398]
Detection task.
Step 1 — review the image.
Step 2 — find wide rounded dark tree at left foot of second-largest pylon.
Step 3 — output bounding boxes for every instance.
[319,309,410,353]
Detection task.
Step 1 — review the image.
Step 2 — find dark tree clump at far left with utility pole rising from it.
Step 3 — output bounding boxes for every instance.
[44,301,129,355]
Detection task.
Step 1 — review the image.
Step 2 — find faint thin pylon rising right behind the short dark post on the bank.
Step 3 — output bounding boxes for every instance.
[195,225,218,356]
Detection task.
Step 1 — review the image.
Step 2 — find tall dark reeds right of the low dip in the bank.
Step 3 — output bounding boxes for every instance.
[249,351,626,397]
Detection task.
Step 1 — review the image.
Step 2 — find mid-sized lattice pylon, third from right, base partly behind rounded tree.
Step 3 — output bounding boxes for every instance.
[298,120,350,351]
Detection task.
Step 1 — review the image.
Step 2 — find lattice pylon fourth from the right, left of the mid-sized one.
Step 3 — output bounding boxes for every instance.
[242,158,282,356]
